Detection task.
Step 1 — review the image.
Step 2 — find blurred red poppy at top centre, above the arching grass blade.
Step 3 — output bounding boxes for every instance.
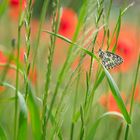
[59,8,78,39]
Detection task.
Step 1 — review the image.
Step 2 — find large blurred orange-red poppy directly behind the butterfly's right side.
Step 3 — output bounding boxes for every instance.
[107,23,139,72]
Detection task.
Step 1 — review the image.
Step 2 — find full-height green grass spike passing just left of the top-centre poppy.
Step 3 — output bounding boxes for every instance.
[42,0,61,139]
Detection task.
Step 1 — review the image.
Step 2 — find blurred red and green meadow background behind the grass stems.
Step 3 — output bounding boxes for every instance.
[0,0,140,140]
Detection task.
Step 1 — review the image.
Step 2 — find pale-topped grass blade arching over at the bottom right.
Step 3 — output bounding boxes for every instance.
[86,112,124,140]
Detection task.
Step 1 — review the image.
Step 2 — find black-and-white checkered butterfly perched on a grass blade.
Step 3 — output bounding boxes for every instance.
[98,49,123,69]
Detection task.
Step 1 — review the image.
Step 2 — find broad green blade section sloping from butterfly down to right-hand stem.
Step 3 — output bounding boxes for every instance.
[102,65,131,124]
